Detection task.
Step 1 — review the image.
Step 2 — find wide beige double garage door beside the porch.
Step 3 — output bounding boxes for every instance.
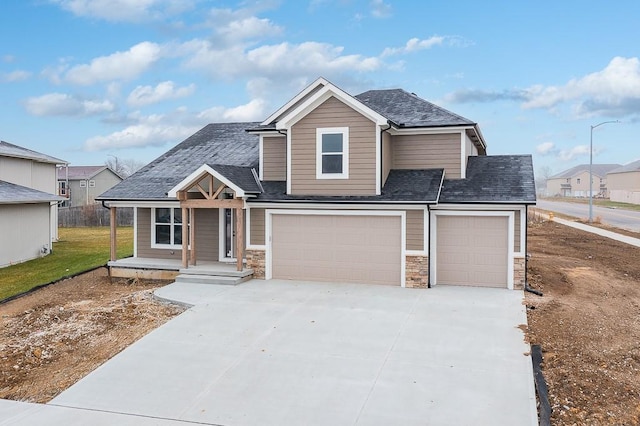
[271,214,402,285]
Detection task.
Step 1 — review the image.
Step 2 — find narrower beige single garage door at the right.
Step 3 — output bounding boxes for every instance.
[436,215,509,287]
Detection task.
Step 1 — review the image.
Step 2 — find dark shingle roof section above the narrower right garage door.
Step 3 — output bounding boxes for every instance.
[440,155,536,204]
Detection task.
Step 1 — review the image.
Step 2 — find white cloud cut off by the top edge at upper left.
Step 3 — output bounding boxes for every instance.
[50,0,193,22]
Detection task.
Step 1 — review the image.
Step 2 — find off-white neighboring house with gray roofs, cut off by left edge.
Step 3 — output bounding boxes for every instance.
[0,141,66,267]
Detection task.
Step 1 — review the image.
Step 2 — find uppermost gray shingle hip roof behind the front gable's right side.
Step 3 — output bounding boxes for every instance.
[355,89,476,127]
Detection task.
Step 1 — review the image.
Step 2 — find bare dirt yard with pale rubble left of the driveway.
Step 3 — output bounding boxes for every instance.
[0,268,184,402]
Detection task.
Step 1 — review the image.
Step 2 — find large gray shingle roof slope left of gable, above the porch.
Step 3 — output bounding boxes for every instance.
[98,123,259,200]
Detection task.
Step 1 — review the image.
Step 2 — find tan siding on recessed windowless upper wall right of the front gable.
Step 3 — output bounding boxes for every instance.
[393,133,462,179]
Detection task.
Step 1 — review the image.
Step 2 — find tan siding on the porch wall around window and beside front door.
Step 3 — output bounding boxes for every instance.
[137,208,218,261]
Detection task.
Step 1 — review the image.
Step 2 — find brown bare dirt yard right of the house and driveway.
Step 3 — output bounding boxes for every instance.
[526,218,640,425]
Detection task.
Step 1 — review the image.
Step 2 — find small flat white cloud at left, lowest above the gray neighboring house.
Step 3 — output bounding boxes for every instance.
[24,93,115,116]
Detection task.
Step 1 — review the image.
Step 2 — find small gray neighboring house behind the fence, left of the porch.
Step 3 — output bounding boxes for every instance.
[58,166,122,207]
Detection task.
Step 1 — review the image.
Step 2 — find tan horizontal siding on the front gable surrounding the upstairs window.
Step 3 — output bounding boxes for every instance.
[290,97,377,195]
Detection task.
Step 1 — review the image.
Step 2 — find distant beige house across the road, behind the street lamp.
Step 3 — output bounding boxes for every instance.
[547,164,620,198]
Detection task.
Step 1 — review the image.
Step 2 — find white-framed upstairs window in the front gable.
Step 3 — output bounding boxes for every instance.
[316,127,349,179]
